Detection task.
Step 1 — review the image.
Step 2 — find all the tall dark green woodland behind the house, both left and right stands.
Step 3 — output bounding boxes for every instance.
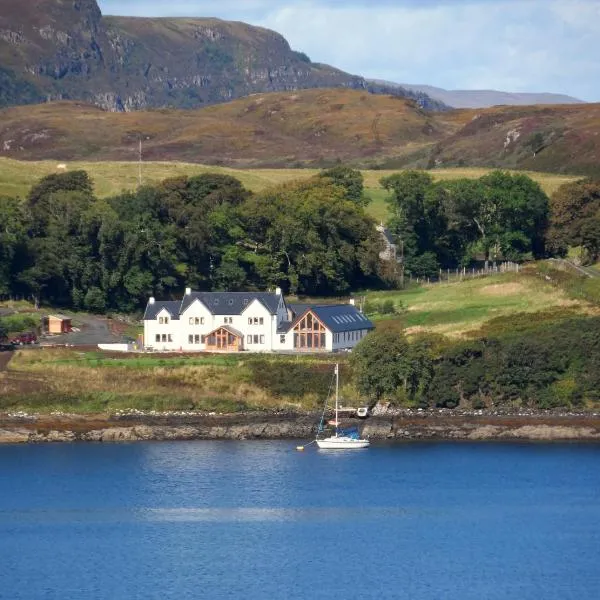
[0,166,600,312]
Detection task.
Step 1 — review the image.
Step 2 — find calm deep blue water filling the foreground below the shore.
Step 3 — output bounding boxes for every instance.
[0,441,600,600]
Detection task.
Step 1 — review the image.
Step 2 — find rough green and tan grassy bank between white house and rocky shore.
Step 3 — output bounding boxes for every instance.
[0,348,344,413]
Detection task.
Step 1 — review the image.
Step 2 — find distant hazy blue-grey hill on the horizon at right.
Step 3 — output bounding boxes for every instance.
[386,82,583,108]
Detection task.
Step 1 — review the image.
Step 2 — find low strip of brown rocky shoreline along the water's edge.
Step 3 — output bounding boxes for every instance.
[0,410,600,444]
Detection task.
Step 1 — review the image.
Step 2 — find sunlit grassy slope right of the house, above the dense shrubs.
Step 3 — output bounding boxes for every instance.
[367,271,597,337]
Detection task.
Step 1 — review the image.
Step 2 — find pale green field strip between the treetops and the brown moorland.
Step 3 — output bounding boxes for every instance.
[0,158,578,221]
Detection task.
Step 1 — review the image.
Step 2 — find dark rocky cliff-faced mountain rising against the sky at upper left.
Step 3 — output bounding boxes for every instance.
[0,0,445,111]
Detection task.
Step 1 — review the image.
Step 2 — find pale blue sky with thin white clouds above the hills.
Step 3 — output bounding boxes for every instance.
[99,0,600,102]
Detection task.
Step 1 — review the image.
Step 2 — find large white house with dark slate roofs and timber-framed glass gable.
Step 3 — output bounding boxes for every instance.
[144,288,373,352]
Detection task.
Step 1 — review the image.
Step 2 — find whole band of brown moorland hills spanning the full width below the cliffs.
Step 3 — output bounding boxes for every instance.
[0,89,600,175]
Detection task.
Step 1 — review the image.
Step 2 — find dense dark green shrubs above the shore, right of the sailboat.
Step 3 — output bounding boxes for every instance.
[350,314,600,409]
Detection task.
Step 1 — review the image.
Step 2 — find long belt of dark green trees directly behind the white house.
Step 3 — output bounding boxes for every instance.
[0,170,381,312]
